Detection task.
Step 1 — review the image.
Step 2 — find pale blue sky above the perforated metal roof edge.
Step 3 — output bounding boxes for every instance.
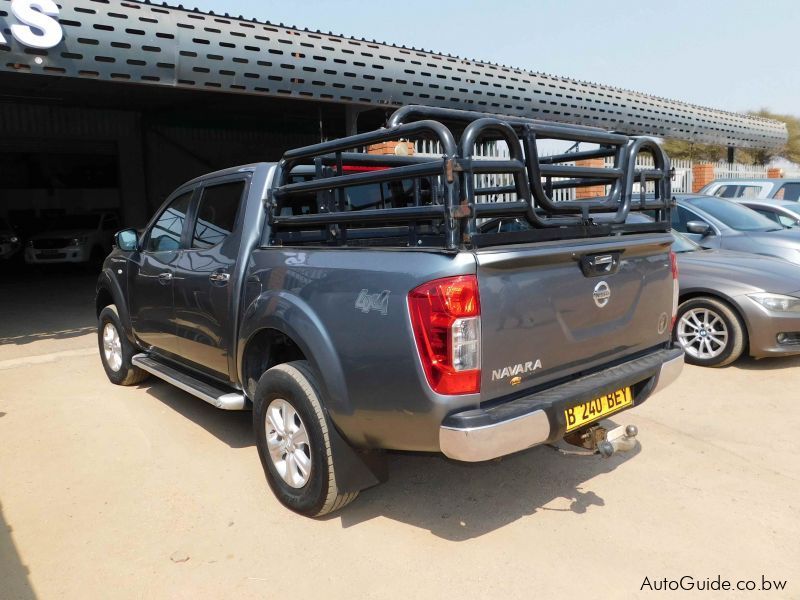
[184,0,800,116]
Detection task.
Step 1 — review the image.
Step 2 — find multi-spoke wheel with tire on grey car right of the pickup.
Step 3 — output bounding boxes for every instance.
[674,297,745,367]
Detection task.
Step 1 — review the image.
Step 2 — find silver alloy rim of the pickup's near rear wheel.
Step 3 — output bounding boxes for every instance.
[266,398,311,489]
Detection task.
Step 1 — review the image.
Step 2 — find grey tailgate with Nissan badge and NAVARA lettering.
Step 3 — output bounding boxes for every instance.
[476,233,673,402]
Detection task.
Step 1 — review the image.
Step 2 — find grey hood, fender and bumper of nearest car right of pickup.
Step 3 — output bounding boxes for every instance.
[678,250,800,358]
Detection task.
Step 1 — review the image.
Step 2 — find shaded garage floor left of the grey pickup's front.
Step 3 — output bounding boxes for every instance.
[0,269,97,345]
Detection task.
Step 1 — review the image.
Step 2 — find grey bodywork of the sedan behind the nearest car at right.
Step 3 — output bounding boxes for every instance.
[674,195,800,265]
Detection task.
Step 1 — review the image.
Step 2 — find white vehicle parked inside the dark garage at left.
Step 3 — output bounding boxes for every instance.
[25,212,120,265]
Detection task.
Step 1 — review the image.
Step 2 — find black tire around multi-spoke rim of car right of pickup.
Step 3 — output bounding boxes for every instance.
[673,296,747,367]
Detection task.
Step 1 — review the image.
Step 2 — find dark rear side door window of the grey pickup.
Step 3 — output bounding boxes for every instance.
[192,180,245,249]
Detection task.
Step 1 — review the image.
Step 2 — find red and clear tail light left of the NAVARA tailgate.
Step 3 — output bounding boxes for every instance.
[408,275,481,394]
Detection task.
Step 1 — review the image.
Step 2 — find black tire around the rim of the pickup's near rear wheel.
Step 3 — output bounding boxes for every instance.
[253,360,358,517]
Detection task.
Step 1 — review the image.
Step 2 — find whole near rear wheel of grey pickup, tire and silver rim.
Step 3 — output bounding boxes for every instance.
[253,360,358,517]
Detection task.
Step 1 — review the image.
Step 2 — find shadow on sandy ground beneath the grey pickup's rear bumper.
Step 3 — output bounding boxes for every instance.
[329,444,640,542]
